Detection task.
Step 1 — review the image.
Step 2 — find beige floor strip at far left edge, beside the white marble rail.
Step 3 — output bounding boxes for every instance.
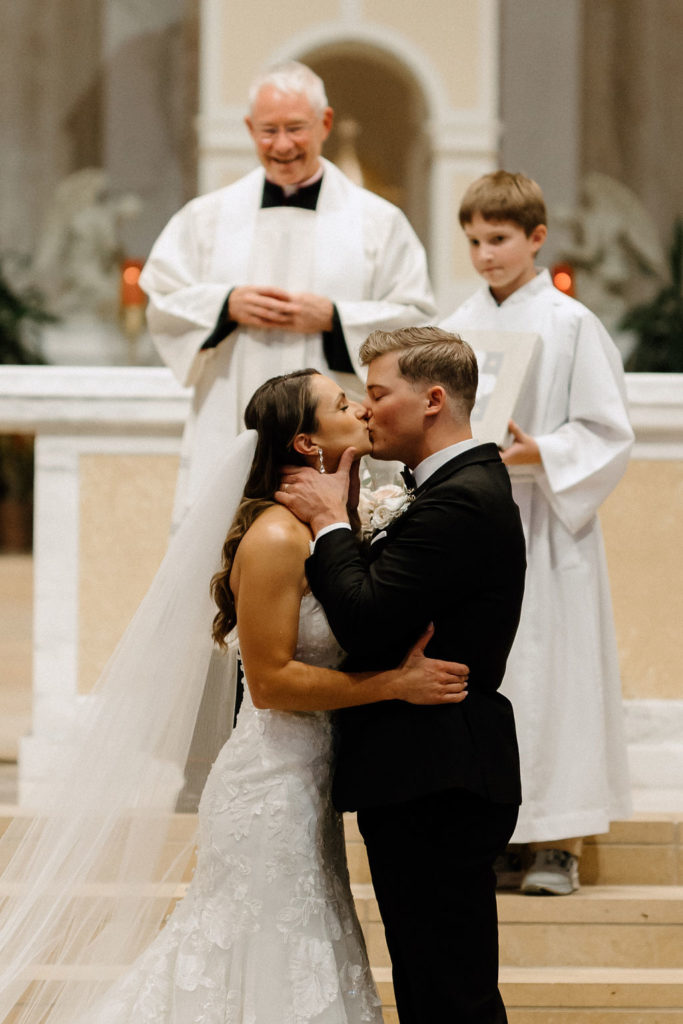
[0,555,33,761]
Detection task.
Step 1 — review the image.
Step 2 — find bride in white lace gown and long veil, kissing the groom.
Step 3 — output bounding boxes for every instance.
[0,370,466,1024]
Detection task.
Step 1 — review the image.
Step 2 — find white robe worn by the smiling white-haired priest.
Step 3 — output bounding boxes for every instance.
[140,161,435,517]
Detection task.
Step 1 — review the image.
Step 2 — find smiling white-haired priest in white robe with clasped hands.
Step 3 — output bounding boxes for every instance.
[140,61,434,520]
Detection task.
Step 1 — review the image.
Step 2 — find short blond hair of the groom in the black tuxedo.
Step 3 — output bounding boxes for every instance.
[358,327,478,417]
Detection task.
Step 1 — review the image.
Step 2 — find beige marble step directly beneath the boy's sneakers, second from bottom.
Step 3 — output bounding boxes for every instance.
[353,885,683,969]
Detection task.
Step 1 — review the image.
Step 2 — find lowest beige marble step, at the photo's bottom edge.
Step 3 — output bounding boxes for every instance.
[374,967,683,1024]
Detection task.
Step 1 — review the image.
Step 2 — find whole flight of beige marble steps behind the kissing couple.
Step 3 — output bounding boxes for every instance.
[0,807,683,1024]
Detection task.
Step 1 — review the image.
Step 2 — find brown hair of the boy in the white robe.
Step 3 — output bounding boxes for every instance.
[459,171,548,238]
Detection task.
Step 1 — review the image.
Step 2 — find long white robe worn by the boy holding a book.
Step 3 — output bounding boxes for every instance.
[442,270,633,843]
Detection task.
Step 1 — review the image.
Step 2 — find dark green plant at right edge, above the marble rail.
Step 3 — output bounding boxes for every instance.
[620,218,683,373]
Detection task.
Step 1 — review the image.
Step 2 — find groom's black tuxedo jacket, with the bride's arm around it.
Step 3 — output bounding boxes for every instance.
[306,444,526,810]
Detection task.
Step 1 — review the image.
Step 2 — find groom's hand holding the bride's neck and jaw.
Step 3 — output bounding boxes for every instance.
[274,447,357,537]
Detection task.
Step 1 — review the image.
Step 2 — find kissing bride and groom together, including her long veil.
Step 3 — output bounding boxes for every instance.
[0,328,525,1024]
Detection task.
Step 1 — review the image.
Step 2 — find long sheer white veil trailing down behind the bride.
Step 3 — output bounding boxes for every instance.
[0,431,256,1024]
